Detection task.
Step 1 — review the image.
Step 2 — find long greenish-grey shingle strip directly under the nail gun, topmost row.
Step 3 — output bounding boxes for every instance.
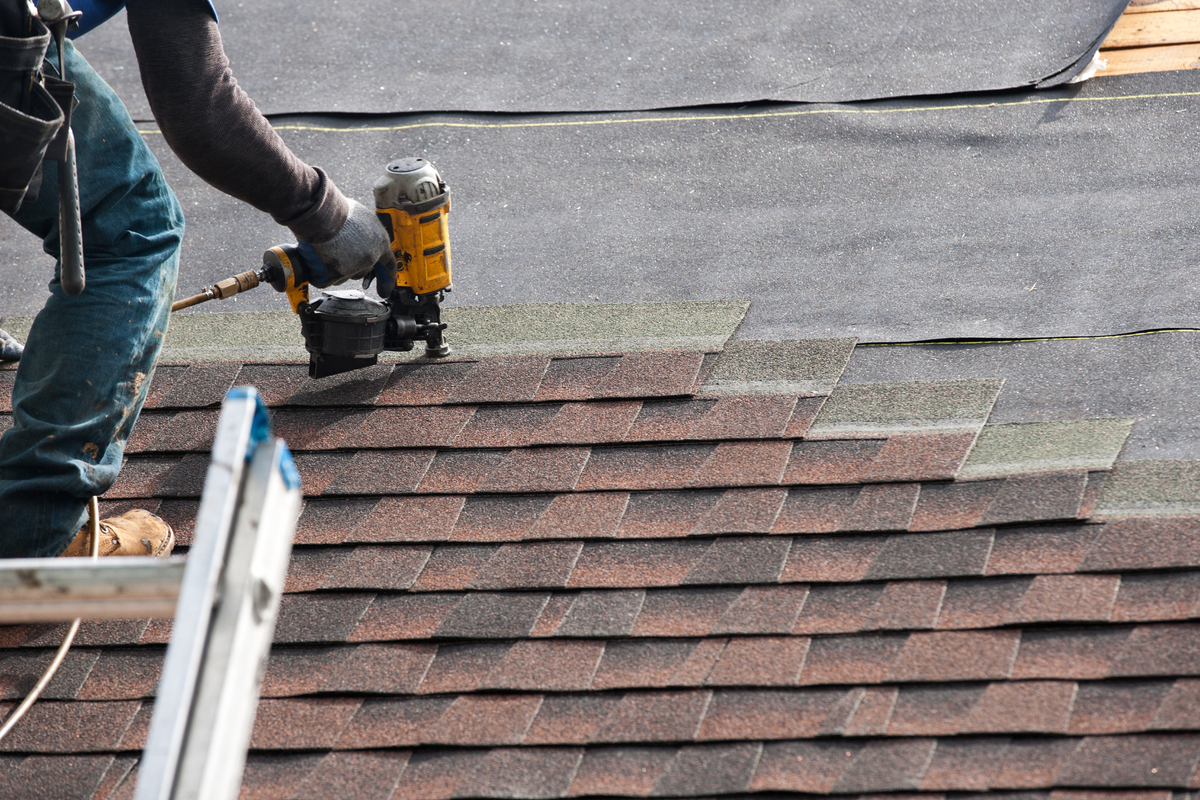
[6,302,748,362]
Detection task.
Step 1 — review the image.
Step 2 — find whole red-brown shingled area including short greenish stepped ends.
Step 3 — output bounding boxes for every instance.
[0,339,1200,800]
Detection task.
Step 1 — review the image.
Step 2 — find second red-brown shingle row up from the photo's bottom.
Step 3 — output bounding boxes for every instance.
[9,679,1200,753]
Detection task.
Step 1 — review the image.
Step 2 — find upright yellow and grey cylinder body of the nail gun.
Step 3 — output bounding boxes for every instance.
[374,158,450,295]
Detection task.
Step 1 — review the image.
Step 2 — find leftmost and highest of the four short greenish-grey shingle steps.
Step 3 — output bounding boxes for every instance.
[700,339,854,396]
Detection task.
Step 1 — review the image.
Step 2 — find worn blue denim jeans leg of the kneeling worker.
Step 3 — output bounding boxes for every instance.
[0,43,184,558]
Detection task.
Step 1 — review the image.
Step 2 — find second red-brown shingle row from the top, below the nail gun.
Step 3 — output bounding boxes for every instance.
[121,395,830,455]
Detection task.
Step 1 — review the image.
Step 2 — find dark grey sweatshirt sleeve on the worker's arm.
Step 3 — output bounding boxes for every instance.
[126,0,349,243]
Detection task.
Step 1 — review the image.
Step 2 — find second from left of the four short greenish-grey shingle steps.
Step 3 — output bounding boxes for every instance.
[805,379,1003,439]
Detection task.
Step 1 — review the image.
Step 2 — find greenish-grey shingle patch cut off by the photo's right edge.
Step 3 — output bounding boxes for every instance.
[1096,461,1200,517]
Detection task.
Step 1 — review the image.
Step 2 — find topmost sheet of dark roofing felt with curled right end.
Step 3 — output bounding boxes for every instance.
[75,0,1126,119]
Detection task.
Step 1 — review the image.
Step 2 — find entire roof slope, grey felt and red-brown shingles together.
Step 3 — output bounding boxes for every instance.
[0,0,1200,800]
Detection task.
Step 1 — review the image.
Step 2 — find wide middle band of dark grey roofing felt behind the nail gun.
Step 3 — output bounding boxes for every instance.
[4,71,1200,342]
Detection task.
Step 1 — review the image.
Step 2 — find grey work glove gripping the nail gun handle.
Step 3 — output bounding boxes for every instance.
[300,200,397,297]
